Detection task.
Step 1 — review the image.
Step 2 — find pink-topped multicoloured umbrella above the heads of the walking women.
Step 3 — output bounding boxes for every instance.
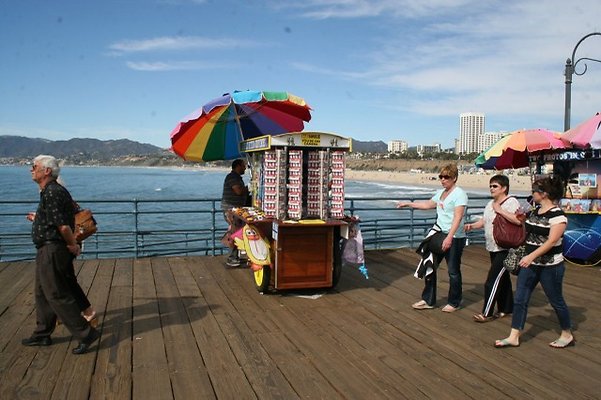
[475,129,571,170]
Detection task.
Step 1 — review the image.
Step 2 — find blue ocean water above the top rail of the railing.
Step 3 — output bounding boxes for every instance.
[0,166,446,201]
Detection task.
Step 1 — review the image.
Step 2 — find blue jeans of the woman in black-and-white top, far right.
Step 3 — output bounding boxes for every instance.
[511,262,572,330]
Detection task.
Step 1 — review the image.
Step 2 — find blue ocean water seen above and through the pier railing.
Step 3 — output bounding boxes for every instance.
[0,166,487,258]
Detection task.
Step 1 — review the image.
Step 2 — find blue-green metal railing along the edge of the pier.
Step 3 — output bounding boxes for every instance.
[0,196,502,261]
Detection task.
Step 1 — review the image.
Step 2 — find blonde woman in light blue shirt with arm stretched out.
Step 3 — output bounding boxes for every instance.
[397,164,468,312]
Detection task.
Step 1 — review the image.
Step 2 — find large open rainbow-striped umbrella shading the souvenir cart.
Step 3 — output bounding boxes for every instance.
[171,90,311,161]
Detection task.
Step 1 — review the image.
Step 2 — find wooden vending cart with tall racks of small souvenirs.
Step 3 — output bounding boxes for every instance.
[230,132,352,292]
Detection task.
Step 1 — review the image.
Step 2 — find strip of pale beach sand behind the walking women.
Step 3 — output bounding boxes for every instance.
[345,168,531,194]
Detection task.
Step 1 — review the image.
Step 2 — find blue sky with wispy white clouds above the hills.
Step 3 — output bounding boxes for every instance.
[0,0,601,148]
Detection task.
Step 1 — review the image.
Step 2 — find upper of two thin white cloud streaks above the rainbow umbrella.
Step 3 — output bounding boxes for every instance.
[109,36,259,54]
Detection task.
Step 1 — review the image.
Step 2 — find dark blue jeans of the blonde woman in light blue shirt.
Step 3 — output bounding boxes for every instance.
[422,238,465,307]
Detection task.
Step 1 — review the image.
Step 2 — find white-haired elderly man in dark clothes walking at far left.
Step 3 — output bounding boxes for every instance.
[21,155,100,354]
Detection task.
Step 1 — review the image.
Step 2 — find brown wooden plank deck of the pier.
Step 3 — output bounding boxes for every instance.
[0,246,601,400]
